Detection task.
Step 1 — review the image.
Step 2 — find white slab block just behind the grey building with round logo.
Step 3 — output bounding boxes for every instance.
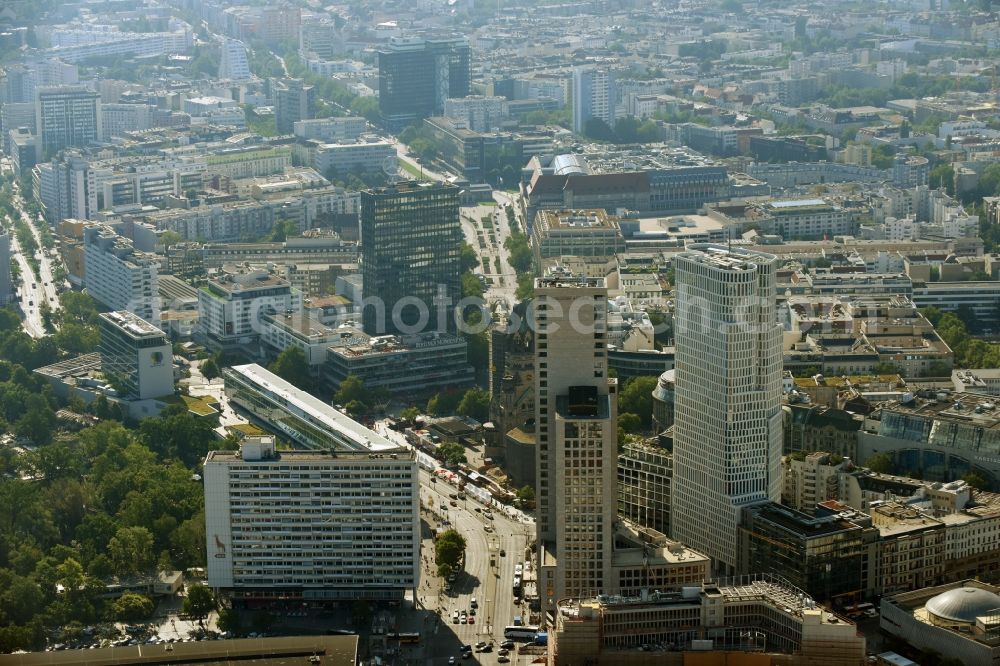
[83,224,160,327]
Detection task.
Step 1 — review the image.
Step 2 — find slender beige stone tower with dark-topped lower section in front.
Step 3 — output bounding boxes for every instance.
[533,277,618,610]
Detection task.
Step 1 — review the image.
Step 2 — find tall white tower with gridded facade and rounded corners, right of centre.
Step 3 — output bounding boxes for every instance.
[671,244,782,574]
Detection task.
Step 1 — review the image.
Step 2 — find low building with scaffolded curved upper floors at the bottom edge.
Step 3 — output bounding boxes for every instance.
[548,576,865,666]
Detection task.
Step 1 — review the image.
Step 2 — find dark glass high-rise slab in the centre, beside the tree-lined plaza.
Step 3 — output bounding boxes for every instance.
[361,181,462,335]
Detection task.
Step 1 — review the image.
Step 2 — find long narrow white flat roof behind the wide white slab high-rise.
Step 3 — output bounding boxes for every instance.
[228,363,400,452]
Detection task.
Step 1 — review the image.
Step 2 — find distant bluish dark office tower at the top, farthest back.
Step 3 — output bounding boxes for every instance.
[378,37,469,131]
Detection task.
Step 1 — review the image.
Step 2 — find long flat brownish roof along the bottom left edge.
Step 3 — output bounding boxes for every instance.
[3,635,358,666]
